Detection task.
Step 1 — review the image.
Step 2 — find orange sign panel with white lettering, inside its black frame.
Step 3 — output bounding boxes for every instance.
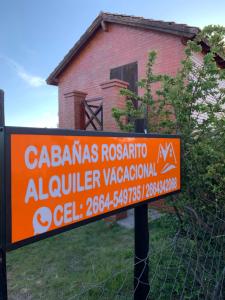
[10,133,180,243]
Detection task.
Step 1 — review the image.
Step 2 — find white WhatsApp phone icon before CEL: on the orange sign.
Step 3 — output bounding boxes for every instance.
[33,207,52,235]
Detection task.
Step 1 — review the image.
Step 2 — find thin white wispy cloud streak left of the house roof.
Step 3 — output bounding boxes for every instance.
[0,56,46,87]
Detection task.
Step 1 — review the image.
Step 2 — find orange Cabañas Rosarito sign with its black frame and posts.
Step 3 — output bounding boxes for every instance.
[0,120,181,300]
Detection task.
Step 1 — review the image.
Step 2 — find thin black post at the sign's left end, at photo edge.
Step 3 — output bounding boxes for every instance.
[0,90,8,300]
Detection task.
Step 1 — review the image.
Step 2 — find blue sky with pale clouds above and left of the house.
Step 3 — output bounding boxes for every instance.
[0,0,225,127]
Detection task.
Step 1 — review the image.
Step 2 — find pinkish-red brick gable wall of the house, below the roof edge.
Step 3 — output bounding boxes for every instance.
[59,24,184,127]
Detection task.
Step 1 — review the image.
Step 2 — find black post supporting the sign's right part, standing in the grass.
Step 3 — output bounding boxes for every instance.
[134,119,150,300]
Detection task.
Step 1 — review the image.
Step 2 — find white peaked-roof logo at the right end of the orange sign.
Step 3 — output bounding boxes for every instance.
[157,143,177,174]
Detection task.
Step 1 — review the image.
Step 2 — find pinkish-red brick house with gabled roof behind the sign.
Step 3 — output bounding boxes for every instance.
[47,13,224,131]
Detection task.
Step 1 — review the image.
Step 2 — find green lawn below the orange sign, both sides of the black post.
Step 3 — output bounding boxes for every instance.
[7,211,186,300]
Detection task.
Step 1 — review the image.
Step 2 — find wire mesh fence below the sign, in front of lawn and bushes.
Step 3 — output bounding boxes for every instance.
[8,199,225,300]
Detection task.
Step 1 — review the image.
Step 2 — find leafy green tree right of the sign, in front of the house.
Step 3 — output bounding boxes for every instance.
[112,25,225,299]
